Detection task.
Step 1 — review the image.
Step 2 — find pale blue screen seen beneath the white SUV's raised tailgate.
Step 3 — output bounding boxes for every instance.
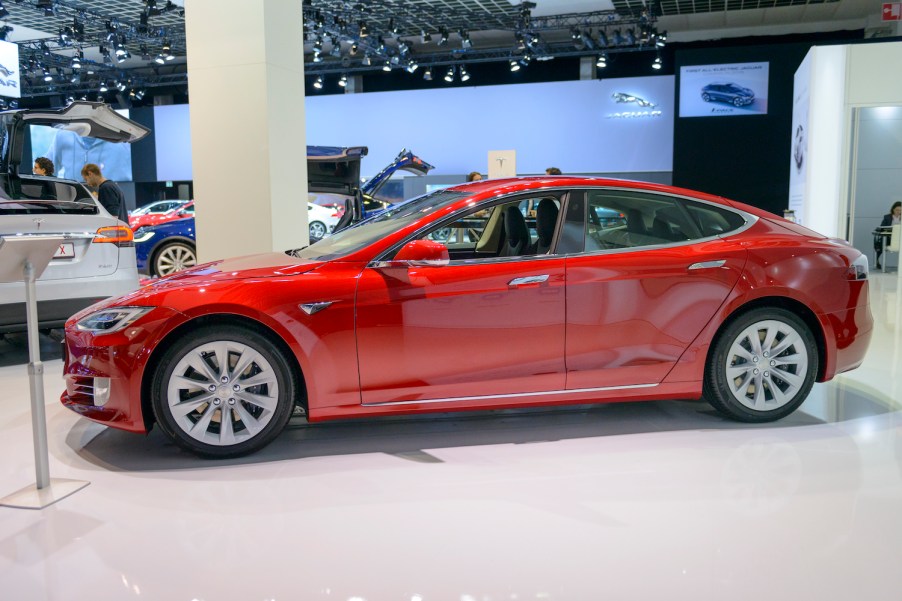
[26,109,132,182]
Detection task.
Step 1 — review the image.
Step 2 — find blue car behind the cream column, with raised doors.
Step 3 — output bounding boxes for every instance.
[135,146,433,276]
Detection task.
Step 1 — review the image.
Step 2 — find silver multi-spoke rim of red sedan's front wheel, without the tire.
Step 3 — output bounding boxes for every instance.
[166,340,279,446]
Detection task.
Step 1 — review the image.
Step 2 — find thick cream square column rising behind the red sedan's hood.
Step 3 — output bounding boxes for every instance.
[185,0,308,261]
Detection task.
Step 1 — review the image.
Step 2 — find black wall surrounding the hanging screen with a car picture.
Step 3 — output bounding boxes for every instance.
[673,31,862,215]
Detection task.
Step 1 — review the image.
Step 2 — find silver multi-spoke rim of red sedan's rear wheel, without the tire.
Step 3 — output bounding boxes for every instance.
[725,319,808,411]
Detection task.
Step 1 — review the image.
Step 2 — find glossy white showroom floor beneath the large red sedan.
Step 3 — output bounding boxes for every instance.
[0,273,902,601]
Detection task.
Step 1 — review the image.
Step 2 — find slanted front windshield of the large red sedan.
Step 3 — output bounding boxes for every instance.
[290,190,468,261]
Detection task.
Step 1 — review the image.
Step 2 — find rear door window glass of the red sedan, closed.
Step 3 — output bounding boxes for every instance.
[585,190,702,252]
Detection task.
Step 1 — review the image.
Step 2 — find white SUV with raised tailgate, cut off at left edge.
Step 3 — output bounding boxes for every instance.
[0,102,148,333]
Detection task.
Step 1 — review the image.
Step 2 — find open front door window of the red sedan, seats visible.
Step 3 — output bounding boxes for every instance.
[422,195,562,260]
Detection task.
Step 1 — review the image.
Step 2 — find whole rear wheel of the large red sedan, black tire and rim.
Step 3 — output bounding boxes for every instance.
[704,307,820,423]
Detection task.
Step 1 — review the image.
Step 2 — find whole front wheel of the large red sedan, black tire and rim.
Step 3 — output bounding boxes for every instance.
[151,325,298,459]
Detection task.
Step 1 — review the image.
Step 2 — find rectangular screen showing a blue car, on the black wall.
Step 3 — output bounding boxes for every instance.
[679,63,769,117]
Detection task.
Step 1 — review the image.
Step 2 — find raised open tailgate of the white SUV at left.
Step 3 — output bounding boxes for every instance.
[0,101,150,173]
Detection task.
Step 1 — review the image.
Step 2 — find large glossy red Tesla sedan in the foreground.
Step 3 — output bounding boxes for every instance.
[62,177,872,457]
